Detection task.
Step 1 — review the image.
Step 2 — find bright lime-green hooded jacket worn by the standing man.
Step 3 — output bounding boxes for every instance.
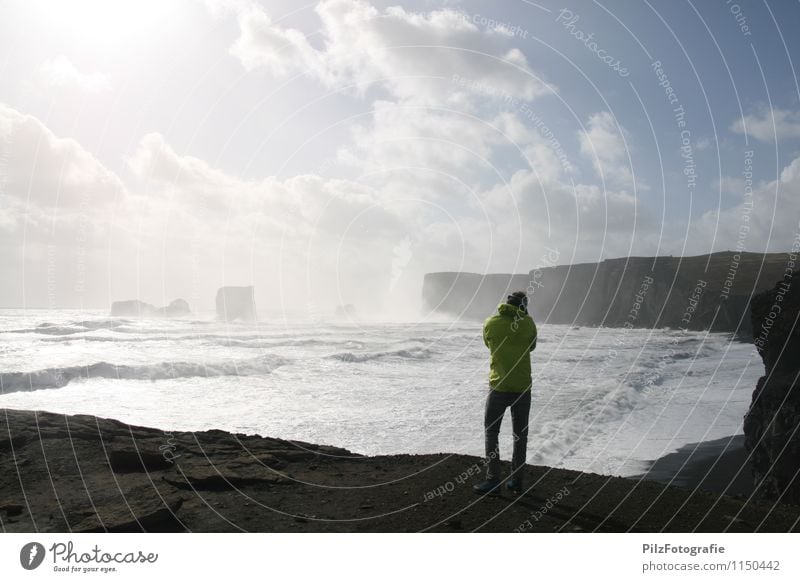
[483,303,536,392]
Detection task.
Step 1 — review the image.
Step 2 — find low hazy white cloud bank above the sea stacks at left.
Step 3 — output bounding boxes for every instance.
[0,106,421,312]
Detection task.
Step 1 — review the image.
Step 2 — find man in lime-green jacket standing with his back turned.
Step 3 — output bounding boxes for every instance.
[474,291,536,494]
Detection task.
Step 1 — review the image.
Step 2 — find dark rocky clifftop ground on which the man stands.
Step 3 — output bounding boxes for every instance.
[0,410,800,532]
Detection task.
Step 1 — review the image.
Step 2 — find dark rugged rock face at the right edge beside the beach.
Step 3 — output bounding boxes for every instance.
[744,271,800,503]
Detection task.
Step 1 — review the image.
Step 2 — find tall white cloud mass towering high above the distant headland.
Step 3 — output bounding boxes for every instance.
[205,0,650,270]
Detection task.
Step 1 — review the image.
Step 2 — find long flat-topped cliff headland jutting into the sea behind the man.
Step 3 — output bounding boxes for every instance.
[422,252,788,336]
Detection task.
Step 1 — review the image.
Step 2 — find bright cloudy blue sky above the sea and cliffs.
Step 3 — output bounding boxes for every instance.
[0,0,800,316]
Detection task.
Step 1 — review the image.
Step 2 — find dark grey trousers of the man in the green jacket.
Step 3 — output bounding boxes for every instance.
[483,390,531,479]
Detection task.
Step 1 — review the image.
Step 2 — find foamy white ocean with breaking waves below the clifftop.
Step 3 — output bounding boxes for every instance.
[0,310,763,476]
